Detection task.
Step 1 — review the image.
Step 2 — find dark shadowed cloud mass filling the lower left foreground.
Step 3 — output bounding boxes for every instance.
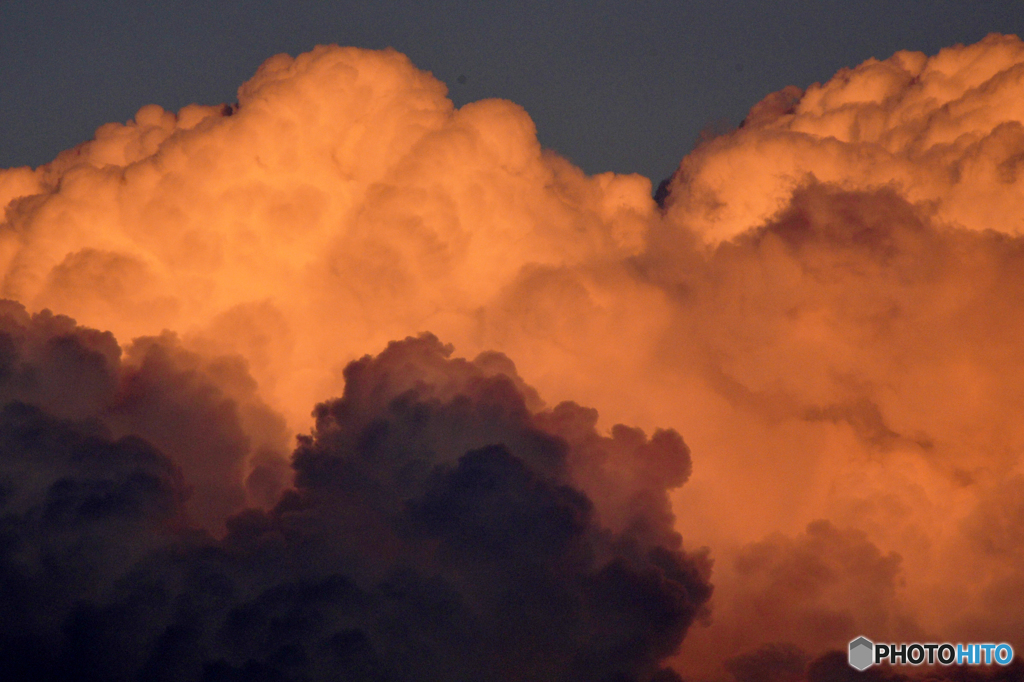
[0,323,711,681]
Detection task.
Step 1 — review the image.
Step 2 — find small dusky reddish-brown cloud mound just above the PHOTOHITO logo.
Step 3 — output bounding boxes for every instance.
[685,520,930,682]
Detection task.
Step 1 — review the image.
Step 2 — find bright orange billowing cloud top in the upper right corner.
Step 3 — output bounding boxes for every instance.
[668,35,1024,243]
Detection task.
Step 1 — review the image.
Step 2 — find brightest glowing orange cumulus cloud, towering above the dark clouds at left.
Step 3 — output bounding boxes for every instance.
[0,47,653,430]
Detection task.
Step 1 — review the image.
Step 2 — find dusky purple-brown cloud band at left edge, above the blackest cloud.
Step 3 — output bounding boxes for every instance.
[0,301,288,529]
